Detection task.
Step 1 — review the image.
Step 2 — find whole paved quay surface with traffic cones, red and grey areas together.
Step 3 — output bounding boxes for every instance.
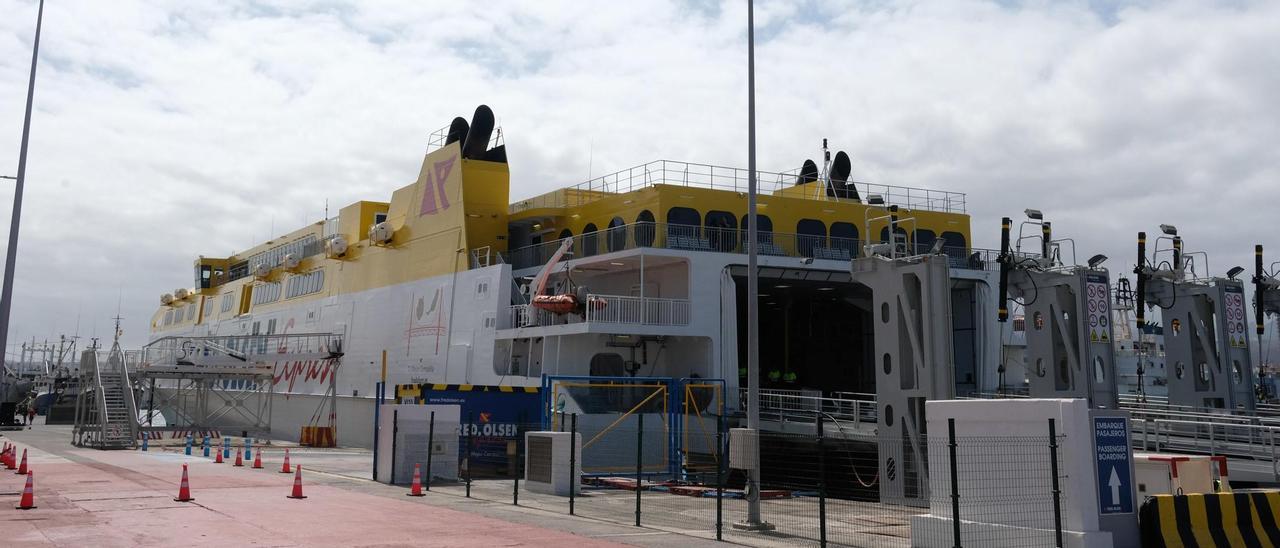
[0,425,723,548]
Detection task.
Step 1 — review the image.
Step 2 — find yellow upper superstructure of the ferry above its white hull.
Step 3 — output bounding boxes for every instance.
[151,112,970,335]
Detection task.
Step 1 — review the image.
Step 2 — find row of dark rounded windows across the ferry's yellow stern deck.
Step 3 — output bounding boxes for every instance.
[545,207,966,259]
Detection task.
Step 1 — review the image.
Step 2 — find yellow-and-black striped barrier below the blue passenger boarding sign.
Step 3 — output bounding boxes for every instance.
[1139,492,1280,548]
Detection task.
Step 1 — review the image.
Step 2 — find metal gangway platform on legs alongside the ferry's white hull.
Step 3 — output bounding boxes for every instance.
[133,333,343,437]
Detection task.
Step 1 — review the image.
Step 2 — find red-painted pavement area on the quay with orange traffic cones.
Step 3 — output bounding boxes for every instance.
[0,449,620,548]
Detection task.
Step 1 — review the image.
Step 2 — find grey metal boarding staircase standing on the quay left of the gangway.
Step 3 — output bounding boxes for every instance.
[72,343,138,449]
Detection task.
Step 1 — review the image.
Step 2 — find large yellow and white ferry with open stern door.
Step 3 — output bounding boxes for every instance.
[151,106,1001,444]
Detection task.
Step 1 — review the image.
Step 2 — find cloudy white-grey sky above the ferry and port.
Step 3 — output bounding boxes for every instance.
[0,0,1280,352]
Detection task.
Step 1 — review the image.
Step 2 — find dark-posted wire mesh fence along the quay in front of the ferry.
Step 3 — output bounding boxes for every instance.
[378,412,1065,548]
